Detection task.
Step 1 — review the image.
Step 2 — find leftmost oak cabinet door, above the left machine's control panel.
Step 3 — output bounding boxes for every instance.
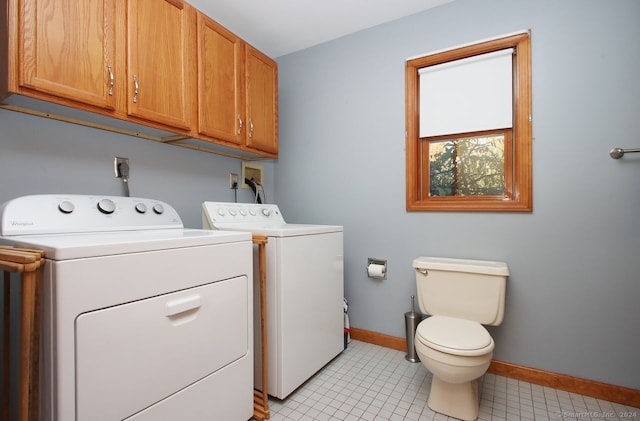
[19,0,115,109]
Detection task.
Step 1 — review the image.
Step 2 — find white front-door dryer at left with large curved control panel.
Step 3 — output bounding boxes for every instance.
[0,195,253,421]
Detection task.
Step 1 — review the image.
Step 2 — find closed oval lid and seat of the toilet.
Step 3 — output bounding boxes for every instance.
[416,315,495,356]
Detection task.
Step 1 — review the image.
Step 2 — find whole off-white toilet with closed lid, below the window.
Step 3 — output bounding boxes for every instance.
[413,257,509,420]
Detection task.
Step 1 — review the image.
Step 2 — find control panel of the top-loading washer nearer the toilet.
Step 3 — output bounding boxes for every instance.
[202,202,285,225]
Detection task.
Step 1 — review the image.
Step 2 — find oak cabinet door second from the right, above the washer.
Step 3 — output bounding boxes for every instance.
[198,13,246,144]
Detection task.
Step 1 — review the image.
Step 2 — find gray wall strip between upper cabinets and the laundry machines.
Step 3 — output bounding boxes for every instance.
[0,109,274,228]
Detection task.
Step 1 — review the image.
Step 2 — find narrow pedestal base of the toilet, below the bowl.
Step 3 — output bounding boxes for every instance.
[427,376,480,421]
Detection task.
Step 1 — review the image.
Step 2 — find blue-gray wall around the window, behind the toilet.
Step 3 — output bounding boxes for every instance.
[275,0,640,389]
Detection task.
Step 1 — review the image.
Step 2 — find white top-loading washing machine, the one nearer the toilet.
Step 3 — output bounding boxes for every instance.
[202,202,344,399]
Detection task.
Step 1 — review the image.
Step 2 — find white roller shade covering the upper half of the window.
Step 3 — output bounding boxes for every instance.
[419,48,513,137]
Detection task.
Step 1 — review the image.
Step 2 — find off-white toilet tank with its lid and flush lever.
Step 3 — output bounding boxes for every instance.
[413,257,509,326]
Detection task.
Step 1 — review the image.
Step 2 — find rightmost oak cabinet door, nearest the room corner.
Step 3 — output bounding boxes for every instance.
[245,45,278,154]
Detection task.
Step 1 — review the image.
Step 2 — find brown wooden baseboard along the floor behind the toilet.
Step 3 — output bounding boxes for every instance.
[350,327,640,408]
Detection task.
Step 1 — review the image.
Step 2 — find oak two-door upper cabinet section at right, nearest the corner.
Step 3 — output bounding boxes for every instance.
[197,13,278,156]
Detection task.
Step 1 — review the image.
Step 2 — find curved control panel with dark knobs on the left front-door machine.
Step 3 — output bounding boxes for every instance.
[0,194,183,236]
